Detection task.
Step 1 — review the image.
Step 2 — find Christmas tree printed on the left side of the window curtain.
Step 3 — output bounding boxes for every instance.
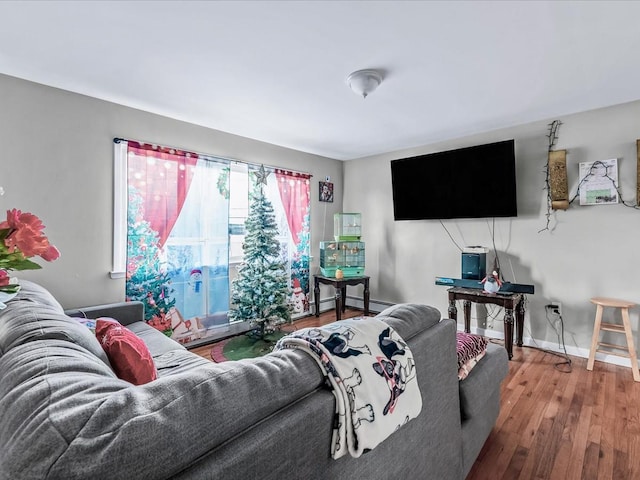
[126,187,176,336]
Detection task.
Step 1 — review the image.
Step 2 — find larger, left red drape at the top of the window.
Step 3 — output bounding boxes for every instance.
[127,141,198,248]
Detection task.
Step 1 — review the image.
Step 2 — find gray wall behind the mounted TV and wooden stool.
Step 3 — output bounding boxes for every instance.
[343,102,640,361]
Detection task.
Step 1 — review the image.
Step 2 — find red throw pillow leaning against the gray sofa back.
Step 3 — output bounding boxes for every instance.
[96,317,158,385]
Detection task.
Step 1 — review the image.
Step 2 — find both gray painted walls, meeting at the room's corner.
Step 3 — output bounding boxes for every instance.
[5,70,640,361]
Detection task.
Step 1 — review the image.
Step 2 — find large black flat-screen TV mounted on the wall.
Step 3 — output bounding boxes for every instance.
[391,140,518,220]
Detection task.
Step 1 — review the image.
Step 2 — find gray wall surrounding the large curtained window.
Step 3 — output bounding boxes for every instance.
[0,75,342,308]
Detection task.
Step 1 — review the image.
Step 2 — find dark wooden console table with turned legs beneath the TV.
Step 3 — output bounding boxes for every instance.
[448,287,525,360]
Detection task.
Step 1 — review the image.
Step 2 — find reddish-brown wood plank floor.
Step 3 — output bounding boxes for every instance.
[192,309,640,480]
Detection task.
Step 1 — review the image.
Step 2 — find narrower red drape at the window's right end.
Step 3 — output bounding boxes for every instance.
[275,169,311,246]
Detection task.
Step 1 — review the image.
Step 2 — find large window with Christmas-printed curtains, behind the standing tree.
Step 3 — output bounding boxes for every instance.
[112,140,310,343]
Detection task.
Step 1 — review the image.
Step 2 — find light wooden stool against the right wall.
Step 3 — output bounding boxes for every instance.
[587,297,640,382]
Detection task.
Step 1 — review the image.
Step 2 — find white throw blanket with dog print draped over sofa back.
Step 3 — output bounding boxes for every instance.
[275,318,422,459]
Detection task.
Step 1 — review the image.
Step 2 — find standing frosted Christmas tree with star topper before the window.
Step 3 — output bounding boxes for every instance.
[229,166,291,339]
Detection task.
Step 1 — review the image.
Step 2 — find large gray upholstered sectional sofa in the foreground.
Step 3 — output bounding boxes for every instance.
[0,282,508,480]
